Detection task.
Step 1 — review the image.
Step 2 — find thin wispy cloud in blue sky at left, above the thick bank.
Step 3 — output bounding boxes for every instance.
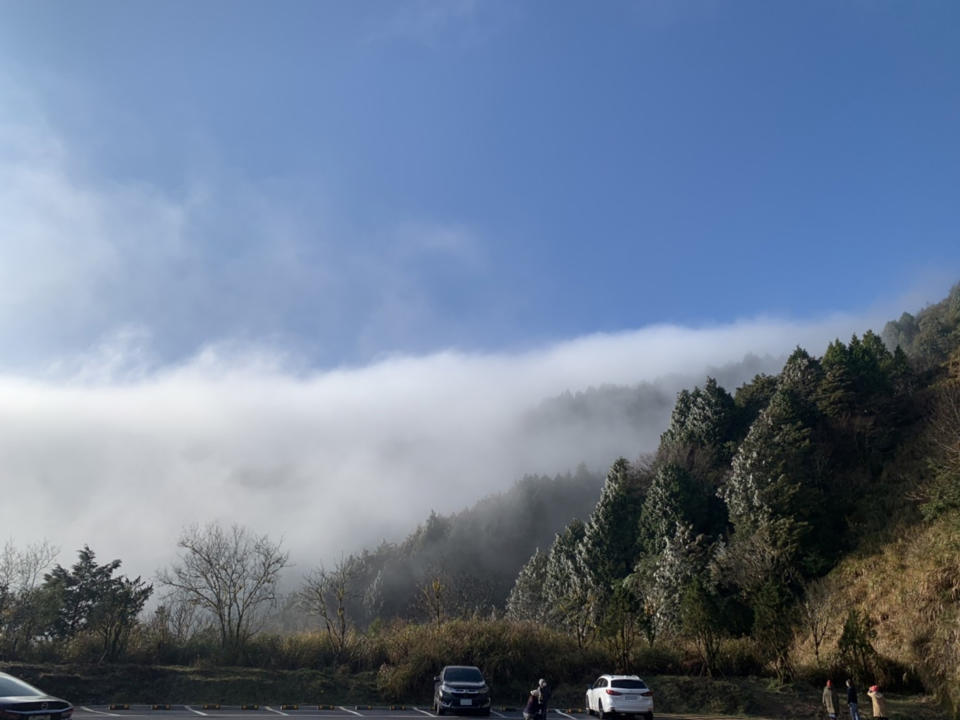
[0,97,496,370]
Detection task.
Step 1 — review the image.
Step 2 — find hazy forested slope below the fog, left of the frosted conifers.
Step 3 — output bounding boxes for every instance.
[294,466,603,627]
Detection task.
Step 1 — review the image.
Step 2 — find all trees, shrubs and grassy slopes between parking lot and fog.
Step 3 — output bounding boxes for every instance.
[0,286,960,718]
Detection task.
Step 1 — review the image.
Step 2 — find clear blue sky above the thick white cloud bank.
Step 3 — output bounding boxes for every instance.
[0,0,960,367]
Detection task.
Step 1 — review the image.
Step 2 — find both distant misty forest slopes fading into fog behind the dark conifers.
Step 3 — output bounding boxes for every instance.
[316,355,782,626]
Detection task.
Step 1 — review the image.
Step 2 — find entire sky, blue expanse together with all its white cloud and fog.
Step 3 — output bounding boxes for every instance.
[0,0,960,575]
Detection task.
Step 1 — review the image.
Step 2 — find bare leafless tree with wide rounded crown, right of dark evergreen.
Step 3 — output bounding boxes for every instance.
[158,523,289,661]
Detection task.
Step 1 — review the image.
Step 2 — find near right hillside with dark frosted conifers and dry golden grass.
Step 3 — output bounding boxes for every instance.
[508,286,960,704]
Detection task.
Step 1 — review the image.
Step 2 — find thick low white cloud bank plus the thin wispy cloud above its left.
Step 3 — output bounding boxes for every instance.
[0,76,936,588]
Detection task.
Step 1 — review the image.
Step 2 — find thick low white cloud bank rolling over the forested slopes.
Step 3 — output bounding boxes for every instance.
[0,310,880,575]
